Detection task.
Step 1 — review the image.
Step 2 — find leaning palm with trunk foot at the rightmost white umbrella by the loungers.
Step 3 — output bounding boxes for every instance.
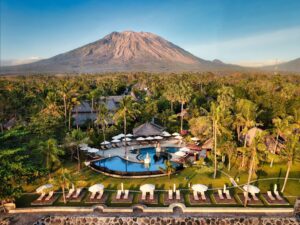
[244,130,267,207]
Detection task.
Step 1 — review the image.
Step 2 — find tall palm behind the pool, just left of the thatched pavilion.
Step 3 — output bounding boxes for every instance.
[114,96,140,157]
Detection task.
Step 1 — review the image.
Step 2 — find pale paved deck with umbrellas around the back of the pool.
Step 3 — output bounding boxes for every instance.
[97,140,185,163]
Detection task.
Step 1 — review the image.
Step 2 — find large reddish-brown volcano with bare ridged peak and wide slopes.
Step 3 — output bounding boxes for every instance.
[1,31,242,73]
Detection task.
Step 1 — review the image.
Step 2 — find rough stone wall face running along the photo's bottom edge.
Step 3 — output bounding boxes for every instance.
[34,216,299,225]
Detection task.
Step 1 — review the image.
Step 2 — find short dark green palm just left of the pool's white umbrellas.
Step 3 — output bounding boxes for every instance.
[65,129,90,171]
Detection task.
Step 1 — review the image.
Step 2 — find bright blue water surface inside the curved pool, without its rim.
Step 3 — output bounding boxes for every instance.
[93,148,181,172]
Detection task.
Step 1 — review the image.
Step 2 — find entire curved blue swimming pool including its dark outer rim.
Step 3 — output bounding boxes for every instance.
[91,148,182,176]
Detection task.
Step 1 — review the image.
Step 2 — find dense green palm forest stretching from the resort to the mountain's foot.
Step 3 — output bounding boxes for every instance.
[0,73,300,202]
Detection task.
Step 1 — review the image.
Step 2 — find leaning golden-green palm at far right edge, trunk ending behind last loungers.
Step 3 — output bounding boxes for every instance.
[280,126,300,192]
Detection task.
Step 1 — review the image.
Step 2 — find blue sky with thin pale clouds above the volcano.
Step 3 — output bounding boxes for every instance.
[0,0,300,66]
